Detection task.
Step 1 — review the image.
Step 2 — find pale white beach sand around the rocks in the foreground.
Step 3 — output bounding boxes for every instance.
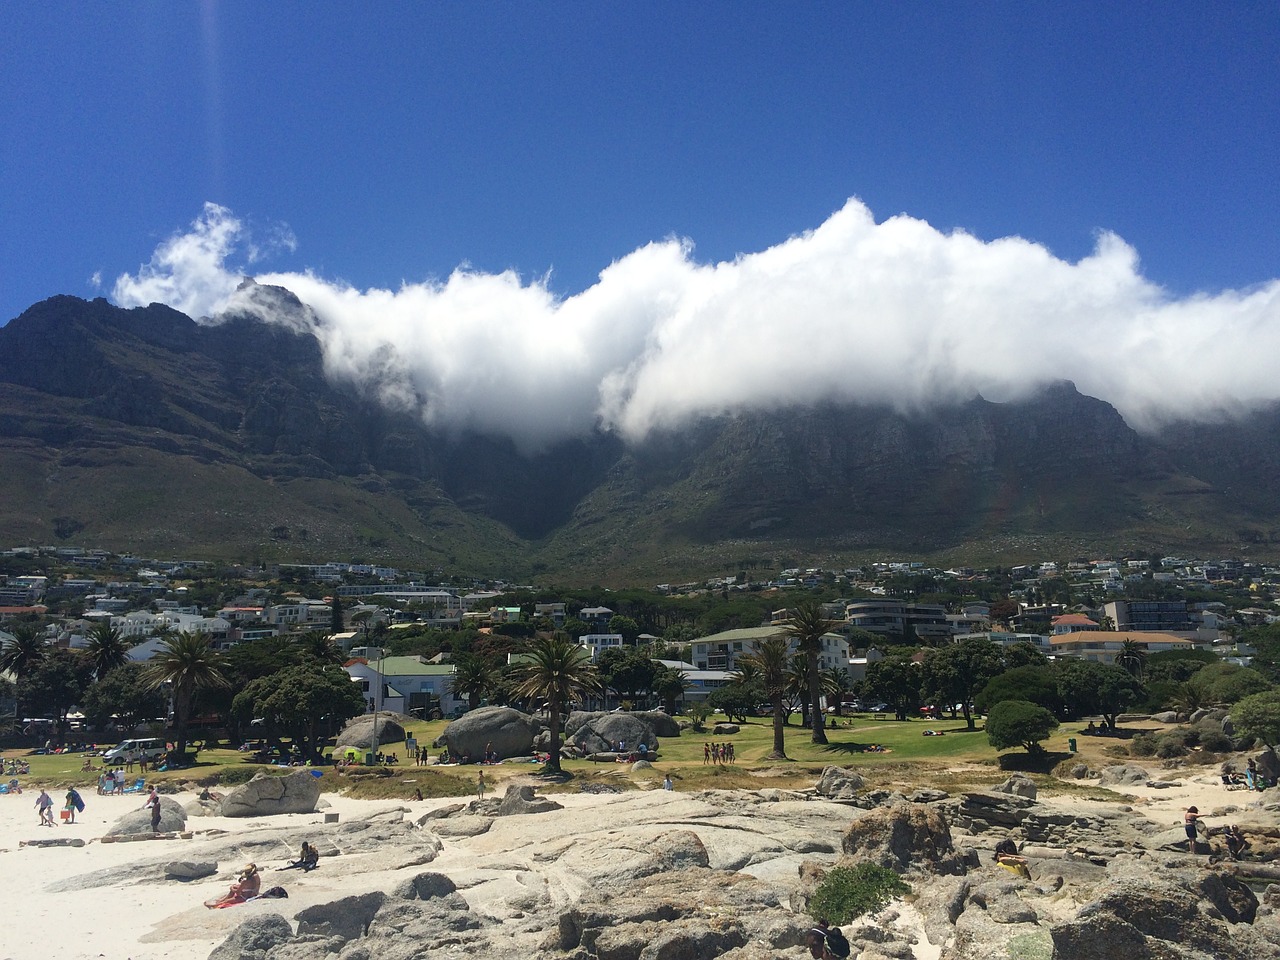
[0,769,1249,960]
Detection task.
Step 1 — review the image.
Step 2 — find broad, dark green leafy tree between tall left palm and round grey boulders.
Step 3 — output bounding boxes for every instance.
[232,663,365,759]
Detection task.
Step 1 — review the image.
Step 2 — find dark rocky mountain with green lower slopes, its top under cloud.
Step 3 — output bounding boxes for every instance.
[0,288,1280,582]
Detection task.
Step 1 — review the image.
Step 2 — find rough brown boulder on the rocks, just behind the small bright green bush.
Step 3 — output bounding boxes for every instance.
[841,804,960,873]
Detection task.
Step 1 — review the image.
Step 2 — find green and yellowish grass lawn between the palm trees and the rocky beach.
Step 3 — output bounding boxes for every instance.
[3,714,1141,799]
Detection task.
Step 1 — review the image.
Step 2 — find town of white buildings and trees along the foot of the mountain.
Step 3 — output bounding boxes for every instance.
[0,547,1280,755]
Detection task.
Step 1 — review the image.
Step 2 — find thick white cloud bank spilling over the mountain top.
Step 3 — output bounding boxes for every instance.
[114,200,1280,449]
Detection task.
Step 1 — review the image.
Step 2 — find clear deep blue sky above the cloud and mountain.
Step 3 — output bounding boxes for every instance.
[0,0,1280,448]
